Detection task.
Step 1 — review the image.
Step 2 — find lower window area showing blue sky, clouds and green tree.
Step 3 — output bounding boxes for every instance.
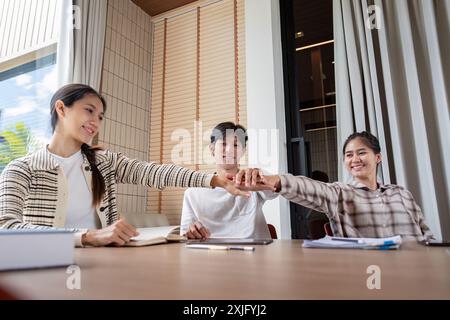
[0,53,57,172]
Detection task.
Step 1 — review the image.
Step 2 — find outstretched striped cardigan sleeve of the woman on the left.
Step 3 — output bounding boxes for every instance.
[114,153,213,190]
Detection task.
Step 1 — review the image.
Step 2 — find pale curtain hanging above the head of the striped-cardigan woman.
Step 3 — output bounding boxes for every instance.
[57,0,107,90]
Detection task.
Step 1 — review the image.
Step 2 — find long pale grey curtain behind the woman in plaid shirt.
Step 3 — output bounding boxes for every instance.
[333,0,450,239]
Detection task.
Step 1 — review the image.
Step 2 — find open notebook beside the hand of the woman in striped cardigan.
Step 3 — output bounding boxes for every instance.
[125,226,186,247]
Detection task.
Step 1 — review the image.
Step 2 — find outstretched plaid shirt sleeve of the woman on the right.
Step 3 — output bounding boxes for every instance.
[280,174,339,218]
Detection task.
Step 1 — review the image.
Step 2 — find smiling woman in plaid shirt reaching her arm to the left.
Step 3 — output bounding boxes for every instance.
[236,131,433,240]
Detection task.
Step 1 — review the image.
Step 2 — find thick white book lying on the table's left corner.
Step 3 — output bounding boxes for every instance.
[0,229,75,270]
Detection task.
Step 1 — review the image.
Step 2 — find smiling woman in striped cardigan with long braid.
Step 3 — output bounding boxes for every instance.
[0,84,256,246]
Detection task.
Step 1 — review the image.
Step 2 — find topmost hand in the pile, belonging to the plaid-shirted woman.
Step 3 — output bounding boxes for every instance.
[234,168,281,192]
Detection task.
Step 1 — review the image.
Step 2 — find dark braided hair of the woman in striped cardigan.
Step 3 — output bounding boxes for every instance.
[50,83,106,207]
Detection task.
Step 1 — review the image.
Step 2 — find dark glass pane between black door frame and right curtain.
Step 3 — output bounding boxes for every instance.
[293,0,338,181]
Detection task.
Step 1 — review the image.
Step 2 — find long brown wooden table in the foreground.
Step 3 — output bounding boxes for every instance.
[0,240,450,300]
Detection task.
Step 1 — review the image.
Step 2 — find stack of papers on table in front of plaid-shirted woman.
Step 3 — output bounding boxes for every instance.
[303,236,402,250]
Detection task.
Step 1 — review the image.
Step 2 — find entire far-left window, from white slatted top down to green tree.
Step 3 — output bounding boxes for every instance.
[0,0,62,172]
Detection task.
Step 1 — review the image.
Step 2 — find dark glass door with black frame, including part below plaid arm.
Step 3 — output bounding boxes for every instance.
[280,0,337,239]
